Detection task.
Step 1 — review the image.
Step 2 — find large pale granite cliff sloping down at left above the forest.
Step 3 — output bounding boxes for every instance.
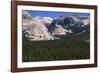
[22,11,53,41]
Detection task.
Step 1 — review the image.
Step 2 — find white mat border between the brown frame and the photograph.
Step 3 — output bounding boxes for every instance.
[17,5,94,68]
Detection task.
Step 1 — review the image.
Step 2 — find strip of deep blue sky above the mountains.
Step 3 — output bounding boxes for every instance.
[24,10,90,18]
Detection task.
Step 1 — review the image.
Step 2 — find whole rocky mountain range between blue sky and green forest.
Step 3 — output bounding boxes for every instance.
[22,11,90,41]
